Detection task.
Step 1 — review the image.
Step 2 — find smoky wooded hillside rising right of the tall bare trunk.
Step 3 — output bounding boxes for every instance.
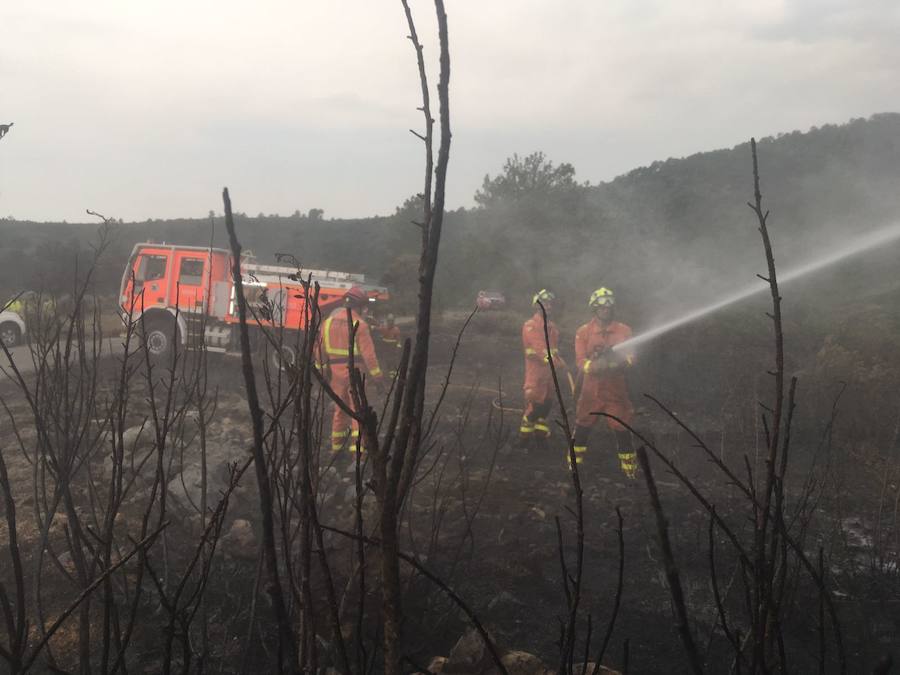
[448,114,900,320]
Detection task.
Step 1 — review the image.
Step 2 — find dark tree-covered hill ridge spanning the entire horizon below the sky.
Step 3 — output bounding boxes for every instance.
[0,113,900,312]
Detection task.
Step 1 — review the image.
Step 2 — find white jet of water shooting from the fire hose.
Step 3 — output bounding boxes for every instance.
[613,223,900,351]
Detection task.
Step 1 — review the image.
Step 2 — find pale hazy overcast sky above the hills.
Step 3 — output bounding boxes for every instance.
[0,0,900,227]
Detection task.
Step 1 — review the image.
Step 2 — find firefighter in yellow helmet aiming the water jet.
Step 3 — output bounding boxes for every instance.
[573,288,637,478]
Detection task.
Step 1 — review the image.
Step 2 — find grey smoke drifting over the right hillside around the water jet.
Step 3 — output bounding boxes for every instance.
[541,115,900,348]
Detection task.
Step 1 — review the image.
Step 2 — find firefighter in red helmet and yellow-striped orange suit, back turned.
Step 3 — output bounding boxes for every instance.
[319,286,384,452]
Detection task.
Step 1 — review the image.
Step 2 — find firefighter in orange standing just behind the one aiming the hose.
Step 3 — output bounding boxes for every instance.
[519,289,566,446]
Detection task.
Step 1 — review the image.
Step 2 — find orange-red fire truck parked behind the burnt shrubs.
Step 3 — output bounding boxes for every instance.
[119,242,389,365]
